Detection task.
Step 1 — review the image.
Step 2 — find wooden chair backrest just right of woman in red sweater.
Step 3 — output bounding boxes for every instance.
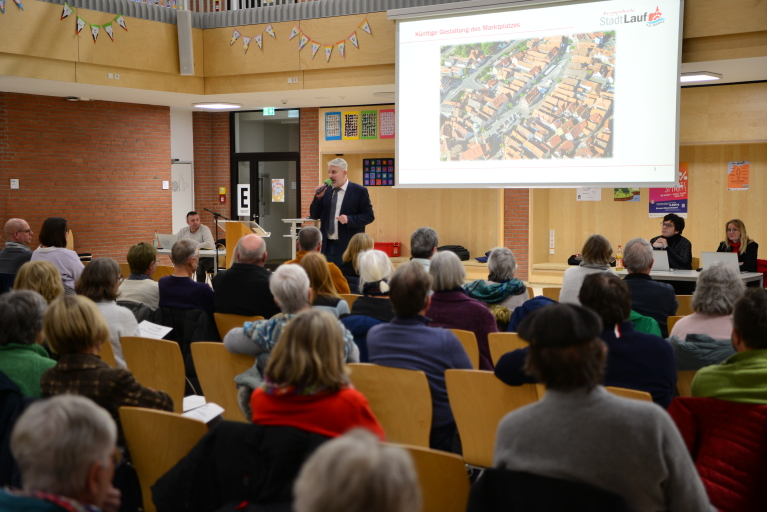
[349,363,432,448]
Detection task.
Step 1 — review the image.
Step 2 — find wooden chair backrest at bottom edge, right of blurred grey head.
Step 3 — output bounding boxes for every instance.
[398,445,470,512]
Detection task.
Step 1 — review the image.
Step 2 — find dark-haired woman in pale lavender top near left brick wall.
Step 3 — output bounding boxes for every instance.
[30,217,83,295]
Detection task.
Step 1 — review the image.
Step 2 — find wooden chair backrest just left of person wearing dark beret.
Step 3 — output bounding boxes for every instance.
[445,370,538,467]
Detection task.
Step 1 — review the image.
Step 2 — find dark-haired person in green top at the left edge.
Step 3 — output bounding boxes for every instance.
[0,290,56,398]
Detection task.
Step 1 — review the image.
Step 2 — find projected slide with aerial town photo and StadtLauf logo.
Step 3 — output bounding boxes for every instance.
[396,0,682,187]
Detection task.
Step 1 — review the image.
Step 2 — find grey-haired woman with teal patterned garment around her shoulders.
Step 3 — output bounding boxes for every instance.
[464,247,528,330]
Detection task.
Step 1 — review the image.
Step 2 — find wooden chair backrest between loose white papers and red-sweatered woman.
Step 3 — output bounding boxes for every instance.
[192,341,255,422]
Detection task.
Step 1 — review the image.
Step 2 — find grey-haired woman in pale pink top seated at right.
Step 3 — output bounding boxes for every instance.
[668,261,746,370]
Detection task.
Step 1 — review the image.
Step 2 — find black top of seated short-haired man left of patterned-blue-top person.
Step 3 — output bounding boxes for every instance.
[213,263,280,318]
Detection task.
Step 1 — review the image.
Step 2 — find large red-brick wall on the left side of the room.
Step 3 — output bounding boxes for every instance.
[0,92,171,262]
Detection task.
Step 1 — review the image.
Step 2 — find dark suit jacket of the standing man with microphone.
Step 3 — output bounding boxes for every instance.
[309,181,375,254]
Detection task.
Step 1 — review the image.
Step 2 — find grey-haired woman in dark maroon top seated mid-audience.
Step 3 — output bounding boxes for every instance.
[426,251,498,370]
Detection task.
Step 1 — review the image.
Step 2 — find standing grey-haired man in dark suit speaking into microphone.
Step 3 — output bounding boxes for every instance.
[309,158,375,266]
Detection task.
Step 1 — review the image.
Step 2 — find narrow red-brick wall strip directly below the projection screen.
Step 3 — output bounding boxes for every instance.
[503,188,530,281]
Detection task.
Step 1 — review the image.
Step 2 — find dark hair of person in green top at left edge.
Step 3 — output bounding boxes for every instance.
[0,290,48,347]
